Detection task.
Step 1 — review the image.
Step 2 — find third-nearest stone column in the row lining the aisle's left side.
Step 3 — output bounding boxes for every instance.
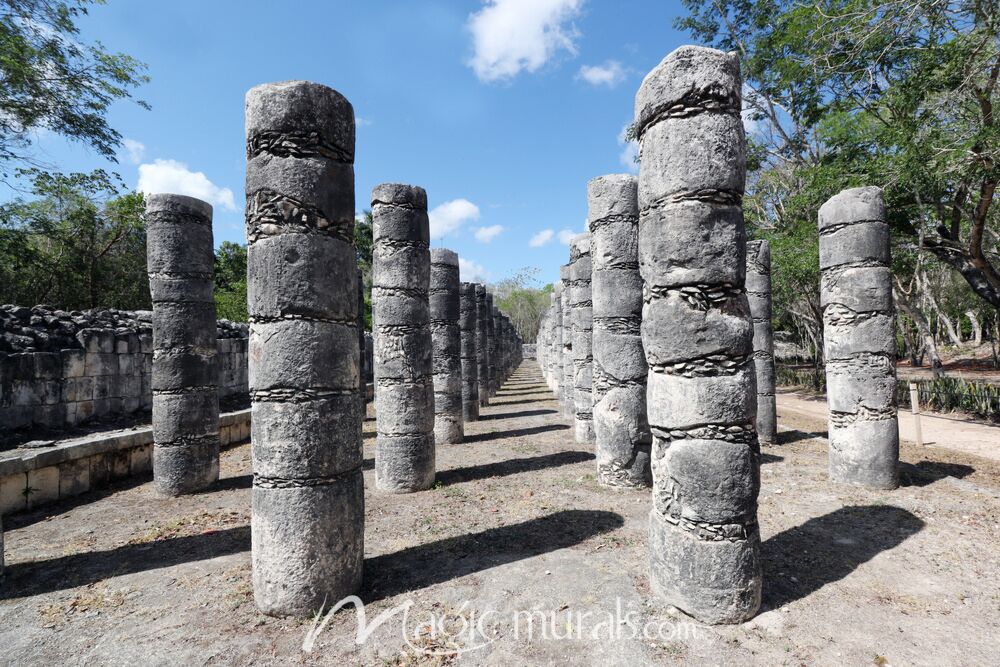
[429,248,463,444]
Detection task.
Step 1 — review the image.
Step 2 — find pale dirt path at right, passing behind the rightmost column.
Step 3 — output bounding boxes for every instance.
[777,391,1000,461]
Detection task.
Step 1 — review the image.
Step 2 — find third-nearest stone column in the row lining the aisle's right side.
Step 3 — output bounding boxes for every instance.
[569,234,594,442]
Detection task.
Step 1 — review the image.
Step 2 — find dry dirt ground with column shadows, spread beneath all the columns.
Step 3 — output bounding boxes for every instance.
[0,362,1000,665]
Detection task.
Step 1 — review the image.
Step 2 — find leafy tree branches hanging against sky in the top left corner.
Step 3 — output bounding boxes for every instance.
[0,0,148,178]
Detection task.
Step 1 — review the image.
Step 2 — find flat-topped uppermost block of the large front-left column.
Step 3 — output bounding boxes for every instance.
[246,81,354,163]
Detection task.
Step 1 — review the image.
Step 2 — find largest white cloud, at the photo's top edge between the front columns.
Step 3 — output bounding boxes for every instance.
[467,0,583,81]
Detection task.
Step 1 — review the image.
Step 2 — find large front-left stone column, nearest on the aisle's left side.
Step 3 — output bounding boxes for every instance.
[246,81,364,616]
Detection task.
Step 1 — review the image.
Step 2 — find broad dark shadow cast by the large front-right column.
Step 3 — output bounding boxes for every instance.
[761,505,925,609]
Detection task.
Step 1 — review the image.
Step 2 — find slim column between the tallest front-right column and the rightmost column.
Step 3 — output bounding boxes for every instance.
[746,241,778,445]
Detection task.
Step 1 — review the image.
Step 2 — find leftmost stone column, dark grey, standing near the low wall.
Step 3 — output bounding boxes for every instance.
[146,194,219,496]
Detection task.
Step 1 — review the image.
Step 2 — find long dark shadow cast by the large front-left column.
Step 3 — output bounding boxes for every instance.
[360,510,625,603]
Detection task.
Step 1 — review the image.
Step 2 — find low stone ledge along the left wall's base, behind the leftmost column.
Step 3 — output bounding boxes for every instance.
[0,409,250,515]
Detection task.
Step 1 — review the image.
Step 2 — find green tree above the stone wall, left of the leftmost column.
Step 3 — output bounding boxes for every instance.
[0,170,150,310]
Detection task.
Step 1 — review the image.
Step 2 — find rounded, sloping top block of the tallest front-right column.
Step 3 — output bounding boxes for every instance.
[635,45,743,137]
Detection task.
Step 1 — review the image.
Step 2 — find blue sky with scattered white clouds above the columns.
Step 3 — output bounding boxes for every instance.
[19,0,690,283]
